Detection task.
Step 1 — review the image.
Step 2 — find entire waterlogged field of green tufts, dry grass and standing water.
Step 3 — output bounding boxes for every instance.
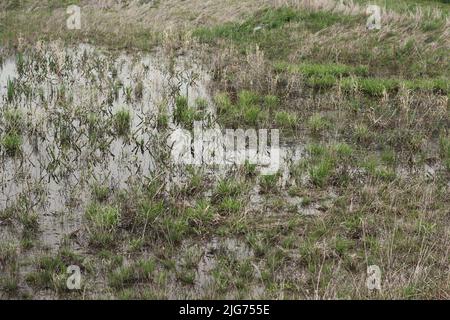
[0,0,450,299]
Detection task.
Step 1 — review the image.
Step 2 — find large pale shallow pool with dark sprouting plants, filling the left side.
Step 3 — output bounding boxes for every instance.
[0,43,304,254]
